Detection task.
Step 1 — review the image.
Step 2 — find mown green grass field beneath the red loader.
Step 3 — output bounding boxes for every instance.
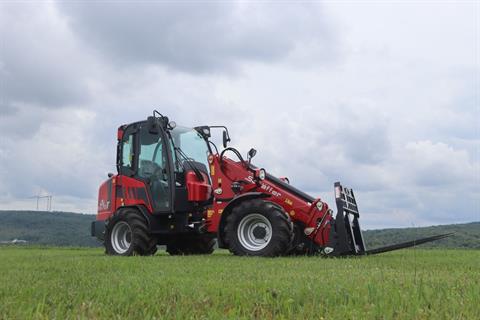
[0,247,480,319]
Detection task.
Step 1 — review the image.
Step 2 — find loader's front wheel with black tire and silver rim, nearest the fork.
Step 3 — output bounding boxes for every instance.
[224,199,293,257]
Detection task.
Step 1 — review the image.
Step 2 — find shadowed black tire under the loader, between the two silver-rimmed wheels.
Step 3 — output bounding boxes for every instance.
[167,235,217,256]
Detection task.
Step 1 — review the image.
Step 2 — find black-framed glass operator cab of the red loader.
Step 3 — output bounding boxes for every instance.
[117,115,212,214]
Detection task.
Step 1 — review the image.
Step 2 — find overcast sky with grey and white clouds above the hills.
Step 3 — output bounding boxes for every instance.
[0,1,480,228]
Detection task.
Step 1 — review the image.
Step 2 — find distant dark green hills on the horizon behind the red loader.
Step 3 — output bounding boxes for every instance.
[0,210,480,249]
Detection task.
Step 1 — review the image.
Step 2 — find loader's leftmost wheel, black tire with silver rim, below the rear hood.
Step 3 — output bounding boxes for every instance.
[104,208,157,256]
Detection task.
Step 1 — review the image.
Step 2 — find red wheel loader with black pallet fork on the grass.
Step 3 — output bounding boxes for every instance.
[91,111,454,257]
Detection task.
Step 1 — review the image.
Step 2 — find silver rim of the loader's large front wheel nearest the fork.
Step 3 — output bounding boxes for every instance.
[237,213,272,251]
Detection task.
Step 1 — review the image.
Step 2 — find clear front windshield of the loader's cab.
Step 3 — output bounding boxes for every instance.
[170,127,209,172]
